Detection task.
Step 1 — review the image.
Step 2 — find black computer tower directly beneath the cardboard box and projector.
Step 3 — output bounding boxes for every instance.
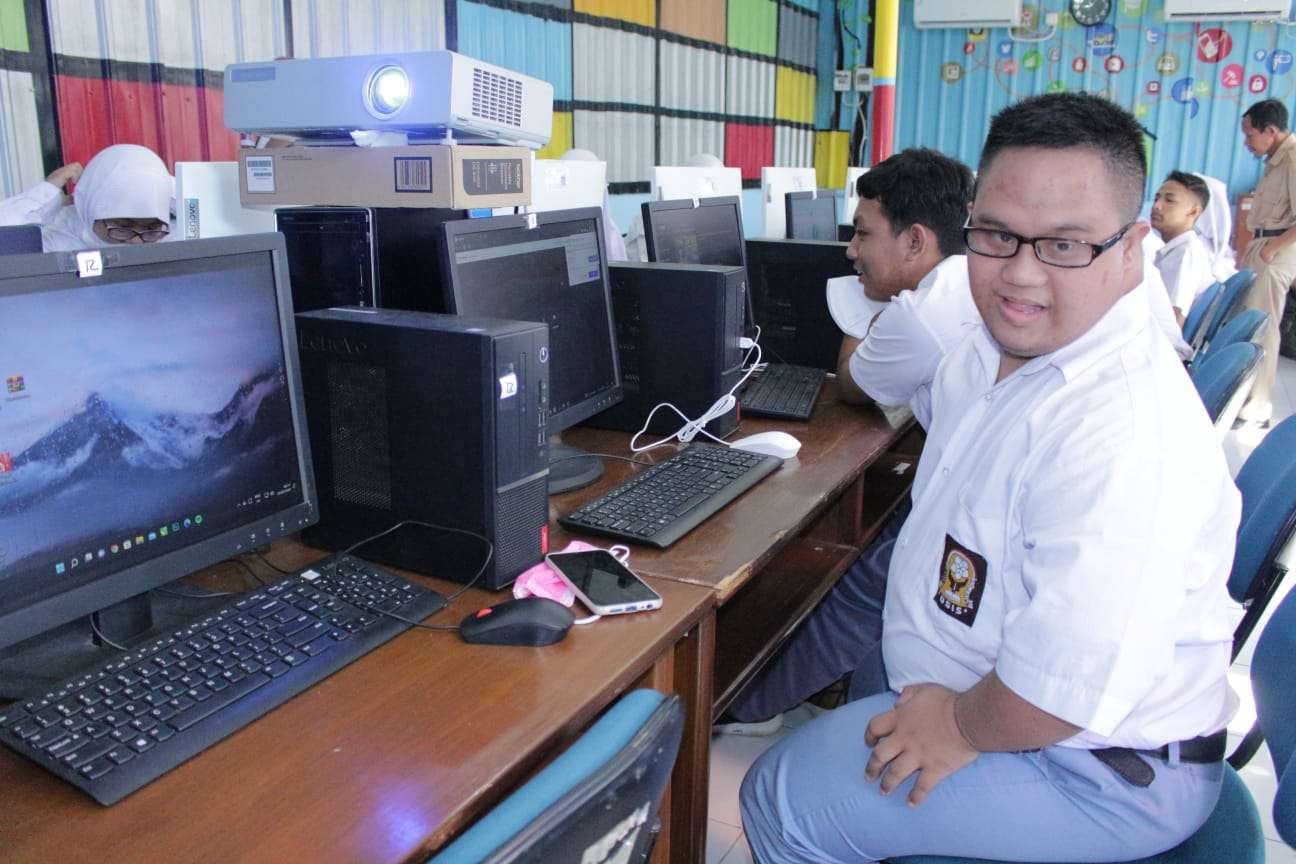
[275,207,465,312]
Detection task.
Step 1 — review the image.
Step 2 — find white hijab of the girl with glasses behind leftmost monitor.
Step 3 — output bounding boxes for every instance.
[41,144,175,253]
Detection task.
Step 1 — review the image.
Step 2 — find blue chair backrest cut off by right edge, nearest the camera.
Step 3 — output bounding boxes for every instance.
[1251,580,1296,846]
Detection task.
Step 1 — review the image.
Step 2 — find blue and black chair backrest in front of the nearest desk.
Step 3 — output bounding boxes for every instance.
[430,690,684,864]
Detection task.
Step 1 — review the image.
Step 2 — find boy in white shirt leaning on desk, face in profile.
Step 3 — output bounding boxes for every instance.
[717,149,980,734]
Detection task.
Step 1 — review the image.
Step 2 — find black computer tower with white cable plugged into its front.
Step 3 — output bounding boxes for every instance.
[586,262,746,437]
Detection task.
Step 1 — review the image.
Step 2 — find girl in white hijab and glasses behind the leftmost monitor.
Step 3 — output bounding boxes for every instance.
[0,144,175,253]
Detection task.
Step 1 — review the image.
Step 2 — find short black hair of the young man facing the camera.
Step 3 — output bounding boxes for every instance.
[980,93,1147,222]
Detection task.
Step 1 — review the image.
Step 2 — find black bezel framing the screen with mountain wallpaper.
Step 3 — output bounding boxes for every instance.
[0,233,319,648]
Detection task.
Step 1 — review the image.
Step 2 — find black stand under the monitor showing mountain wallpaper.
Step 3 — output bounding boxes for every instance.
[0,583,228,699]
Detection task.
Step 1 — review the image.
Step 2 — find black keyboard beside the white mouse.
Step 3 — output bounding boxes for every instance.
[559,444,783,549]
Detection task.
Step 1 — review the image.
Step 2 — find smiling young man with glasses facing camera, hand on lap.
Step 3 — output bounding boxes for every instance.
[741,93,1240,864]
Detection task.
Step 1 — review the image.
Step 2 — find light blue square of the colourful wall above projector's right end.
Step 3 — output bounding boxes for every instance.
[459,3,573,102]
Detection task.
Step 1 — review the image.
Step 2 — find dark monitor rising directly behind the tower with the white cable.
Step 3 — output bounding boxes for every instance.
[642,196,746,267]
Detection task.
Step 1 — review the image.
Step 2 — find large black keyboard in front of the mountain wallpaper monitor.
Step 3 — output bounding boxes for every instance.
[0,556,446,804]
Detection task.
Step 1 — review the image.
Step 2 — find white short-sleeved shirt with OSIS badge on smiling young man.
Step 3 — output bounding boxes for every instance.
[883,285,1240,747]
